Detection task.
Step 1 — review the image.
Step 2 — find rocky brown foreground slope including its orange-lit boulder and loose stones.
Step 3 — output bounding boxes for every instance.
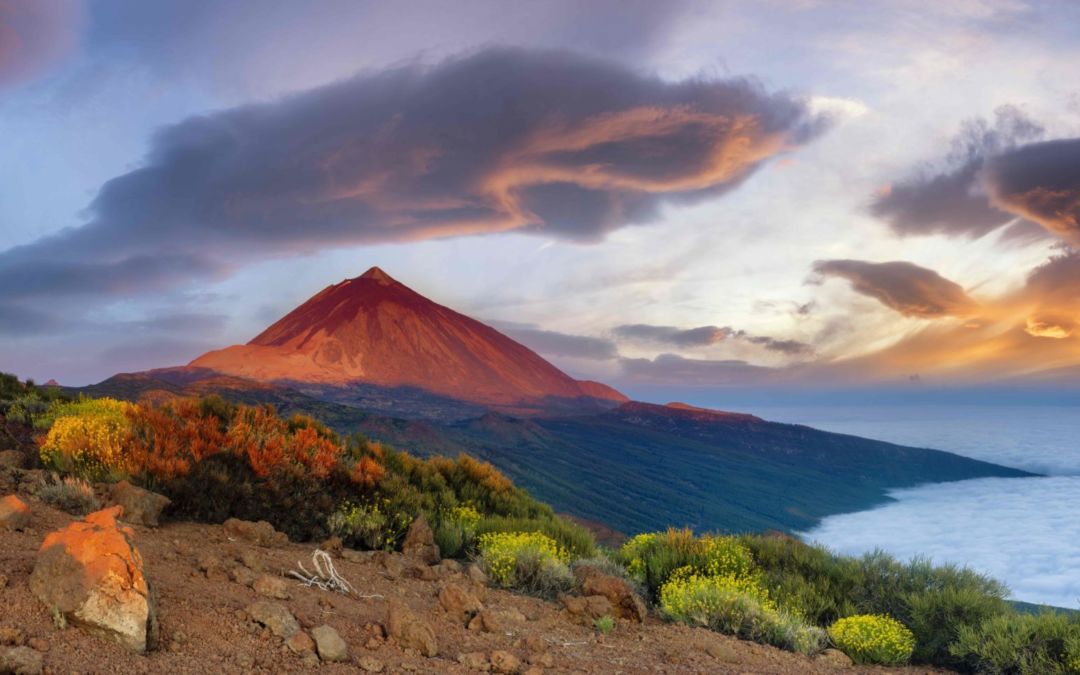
[0,470,902,675]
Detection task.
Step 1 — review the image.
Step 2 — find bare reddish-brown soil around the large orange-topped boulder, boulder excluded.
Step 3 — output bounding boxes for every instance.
[0,495,936,675]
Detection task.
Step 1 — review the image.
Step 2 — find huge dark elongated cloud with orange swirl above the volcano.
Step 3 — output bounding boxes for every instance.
[0,49,827,296]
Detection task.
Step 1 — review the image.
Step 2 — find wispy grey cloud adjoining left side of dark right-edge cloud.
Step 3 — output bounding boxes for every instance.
[870,106,1043,237]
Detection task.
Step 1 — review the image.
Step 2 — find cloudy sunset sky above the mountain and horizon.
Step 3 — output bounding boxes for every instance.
[0,0,1080,402]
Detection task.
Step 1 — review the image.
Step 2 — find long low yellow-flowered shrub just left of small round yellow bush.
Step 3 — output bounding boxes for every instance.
[660,572,824,653]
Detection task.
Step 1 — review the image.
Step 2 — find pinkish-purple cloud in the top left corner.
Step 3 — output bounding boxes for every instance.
[0,0,81,87]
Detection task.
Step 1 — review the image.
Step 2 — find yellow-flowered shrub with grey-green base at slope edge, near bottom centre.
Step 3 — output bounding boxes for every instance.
[478,531,576,597]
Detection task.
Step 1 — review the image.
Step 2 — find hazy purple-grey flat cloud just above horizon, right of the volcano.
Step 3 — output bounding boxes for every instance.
[619,354,779,387]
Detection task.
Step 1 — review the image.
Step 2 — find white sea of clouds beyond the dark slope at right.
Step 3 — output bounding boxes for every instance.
[755,406,1080,609]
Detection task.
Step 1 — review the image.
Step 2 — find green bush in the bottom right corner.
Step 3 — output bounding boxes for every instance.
[949,612,1080,675]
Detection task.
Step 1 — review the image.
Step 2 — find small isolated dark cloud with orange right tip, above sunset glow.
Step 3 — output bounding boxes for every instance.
[813,260,977,319]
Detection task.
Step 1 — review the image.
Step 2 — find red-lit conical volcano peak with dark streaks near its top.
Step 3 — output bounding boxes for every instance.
[189,267,626,406]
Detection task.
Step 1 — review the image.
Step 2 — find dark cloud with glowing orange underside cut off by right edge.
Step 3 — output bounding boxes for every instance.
[986,138,1080,245]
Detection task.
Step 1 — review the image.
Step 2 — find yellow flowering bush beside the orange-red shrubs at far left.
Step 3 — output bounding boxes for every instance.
[40,399,134,481]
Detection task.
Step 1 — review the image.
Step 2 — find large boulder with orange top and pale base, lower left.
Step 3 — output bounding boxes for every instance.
[30,507,158,652]
